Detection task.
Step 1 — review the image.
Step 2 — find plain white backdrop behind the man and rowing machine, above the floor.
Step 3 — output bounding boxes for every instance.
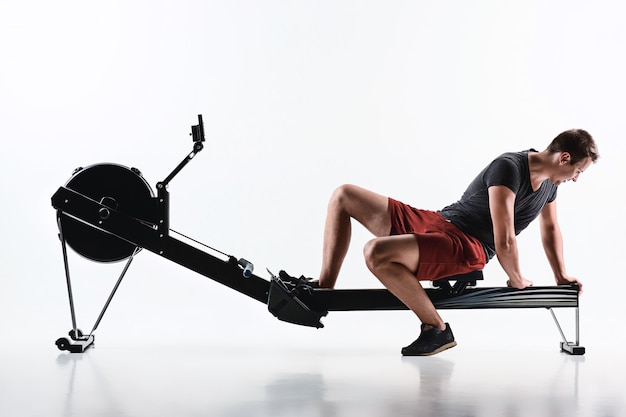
[0,0,626,354]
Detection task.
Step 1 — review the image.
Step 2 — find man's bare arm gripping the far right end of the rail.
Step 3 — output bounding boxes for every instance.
[539,200,583,292]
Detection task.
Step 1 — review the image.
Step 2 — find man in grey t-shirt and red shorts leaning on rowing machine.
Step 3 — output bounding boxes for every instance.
[319,129,599,356]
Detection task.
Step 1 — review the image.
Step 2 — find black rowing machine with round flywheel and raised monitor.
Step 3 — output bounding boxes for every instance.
[52,115,585,355]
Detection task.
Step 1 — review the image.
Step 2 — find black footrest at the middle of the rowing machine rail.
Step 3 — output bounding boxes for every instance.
[267,275,328,329]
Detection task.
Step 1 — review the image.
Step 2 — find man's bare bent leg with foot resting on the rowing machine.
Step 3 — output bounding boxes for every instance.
[319,185,391,288]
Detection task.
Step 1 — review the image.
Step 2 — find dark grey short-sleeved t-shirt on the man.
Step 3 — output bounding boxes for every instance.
[440,149,558,260]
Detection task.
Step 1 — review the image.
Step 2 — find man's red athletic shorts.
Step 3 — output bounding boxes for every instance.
[389,198,487,281]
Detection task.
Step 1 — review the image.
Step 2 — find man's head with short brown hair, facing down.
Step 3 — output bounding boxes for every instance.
[546,129,600,185]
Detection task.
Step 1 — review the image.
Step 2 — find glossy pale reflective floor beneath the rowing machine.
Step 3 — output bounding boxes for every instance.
[0,346,626,417]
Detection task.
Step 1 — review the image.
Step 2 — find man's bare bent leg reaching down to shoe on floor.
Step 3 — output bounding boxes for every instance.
[364,234,446,330]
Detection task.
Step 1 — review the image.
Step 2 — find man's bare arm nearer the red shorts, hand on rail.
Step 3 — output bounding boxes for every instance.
[489,185,533,288]
